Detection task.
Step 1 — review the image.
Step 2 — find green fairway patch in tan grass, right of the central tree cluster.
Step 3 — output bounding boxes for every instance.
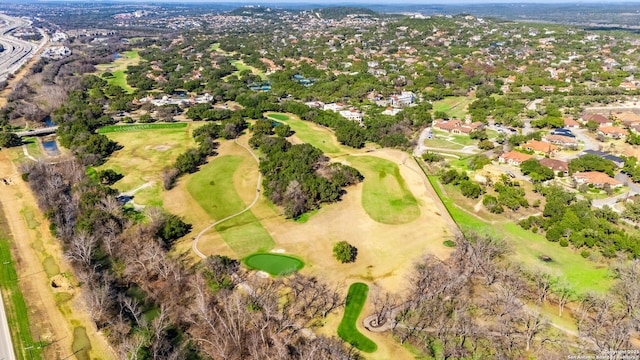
[347,156,420,224]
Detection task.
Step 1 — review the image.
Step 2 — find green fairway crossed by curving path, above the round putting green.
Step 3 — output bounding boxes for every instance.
[187,155,275,257]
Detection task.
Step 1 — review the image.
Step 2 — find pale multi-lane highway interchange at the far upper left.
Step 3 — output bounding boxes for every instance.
[0,14,46,81]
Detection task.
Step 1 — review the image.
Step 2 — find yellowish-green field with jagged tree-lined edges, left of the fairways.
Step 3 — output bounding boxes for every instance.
[97,123,197,206]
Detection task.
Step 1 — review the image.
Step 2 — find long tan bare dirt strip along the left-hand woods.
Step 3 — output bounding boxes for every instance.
[0,151,115,359]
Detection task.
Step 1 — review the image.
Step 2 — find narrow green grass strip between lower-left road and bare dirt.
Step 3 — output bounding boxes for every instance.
[0,202,42,360]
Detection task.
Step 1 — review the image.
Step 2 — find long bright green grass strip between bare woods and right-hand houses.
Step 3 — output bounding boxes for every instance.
[428,170,612,294]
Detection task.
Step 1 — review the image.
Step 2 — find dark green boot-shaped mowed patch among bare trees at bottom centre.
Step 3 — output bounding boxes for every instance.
[338,283,378,353]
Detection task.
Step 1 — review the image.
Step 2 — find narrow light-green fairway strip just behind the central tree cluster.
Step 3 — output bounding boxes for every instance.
[265,113,345,155]
